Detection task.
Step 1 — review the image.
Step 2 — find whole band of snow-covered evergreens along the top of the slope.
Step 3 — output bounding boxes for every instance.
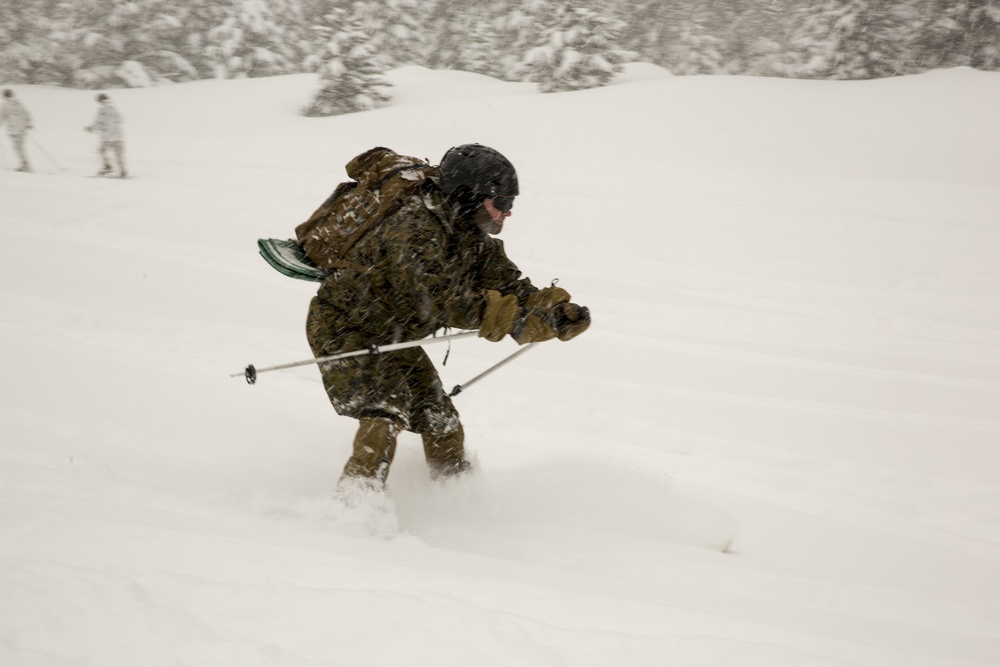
[0,0,1000,115]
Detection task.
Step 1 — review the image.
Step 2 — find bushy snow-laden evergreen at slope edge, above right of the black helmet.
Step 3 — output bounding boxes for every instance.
[523,2,635,93]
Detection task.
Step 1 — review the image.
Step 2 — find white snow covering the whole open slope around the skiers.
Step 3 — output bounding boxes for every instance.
[0,66,1000,667]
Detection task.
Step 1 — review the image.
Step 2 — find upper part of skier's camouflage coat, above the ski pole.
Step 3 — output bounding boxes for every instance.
[309,182,538,349]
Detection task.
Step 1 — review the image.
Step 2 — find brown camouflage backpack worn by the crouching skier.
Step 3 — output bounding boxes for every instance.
[295,146,438,271]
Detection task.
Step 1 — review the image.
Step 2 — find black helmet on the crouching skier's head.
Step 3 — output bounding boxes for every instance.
[439,144,519,206]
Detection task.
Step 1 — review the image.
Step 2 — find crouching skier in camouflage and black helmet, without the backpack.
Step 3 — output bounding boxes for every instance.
[306,144,590,491]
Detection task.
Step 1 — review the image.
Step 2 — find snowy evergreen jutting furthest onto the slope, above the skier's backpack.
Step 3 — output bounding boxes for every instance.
[302,9,391,116]
